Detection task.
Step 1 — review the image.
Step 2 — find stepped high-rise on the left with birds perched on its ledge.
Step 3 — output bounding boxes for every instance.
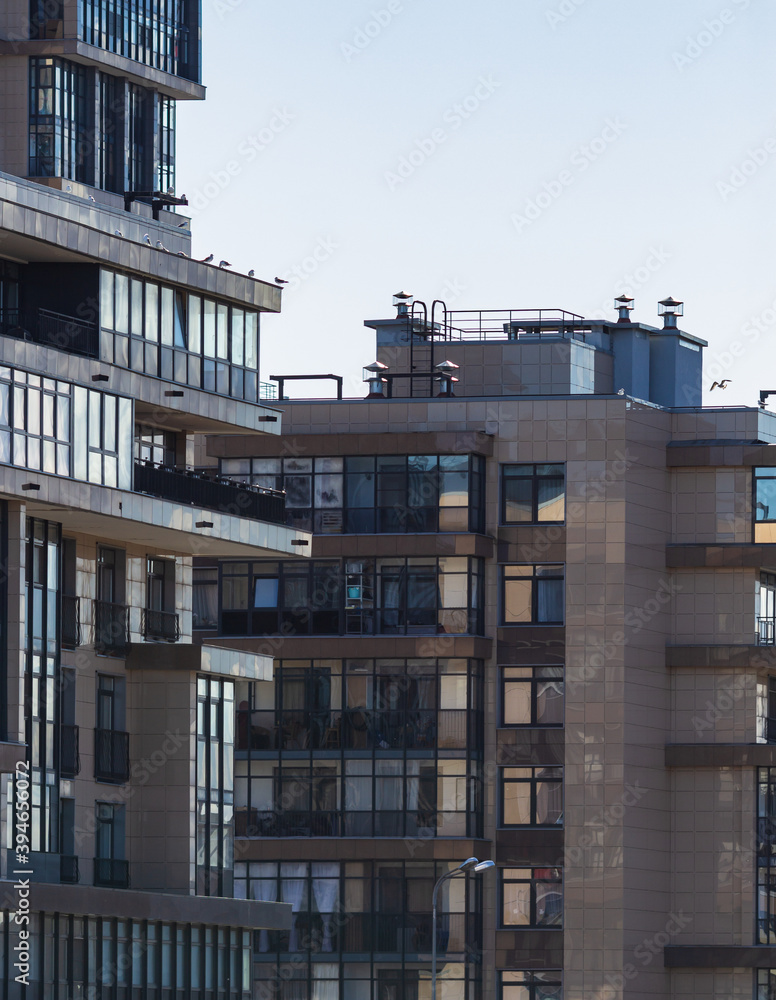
[0,0,309,1000]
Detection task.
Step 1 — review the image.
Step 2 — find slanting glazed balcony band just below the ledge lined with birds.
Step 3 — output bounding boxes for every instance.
[100,270,259,402]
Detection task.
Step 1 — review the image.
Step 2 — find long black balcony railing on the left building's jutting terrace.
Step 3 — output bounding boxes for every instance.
[135,462,286,524]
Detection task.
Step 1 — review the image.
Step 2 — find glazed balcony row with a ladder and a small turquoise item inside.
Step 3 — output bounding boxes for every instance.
[221,557,481,635]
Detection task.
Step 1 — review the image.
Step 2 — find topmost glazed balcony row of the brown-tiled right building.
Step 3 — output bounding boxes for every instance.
[221,455,484,534]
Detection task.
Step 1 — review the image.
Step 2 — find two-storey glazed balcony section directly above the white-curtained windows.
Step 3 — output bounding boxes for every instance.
[235,659,482,839]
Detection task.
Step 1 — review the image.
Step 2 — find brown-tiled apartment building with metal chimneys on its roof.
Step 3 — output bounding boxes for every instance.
[202,294,776,1000]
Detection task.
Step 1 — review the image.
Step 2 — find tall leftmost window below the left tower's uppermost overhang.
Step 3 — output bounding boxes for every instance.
[29,57,91,183]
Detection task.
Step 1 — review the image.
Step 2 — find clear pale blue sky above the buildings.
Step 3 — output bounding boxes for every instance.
[177,0,776,409]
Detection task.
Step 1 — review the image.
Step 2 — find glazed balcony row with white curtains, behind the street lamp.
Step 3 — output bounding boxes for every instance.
[234,861,482,964]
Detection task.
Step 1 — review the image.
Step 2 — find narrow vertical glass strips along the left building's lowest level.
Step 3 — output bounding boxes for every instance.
[0,912,251,1000]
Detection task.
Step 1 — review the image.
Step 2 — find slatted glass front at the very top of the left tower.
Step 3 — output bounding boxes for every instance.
[78,0,199,81]
